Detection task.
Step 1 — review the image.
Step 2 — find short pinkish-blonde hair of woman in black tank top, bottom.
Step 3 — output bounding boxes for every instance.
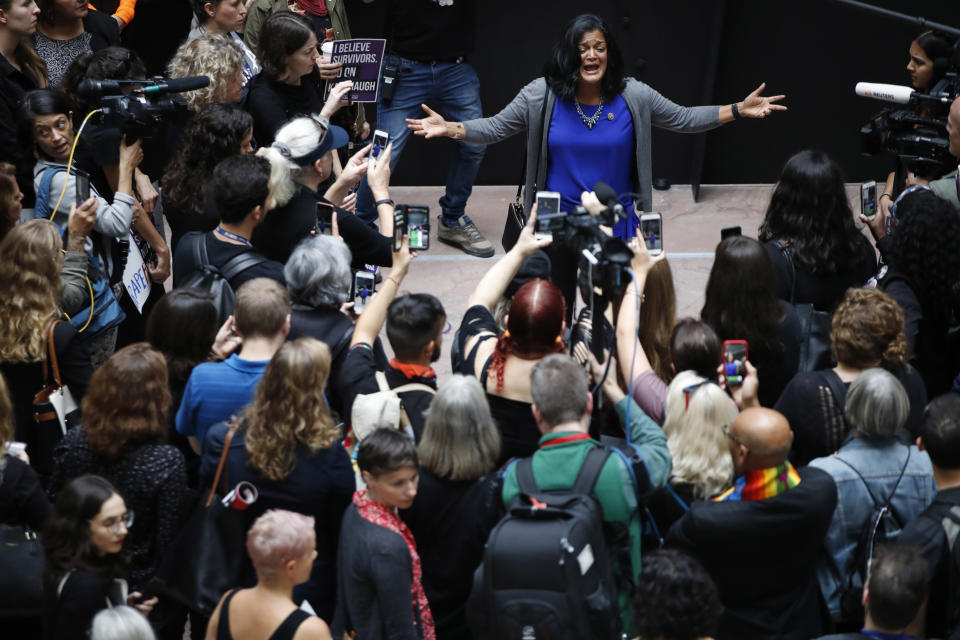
[247,509,316,580]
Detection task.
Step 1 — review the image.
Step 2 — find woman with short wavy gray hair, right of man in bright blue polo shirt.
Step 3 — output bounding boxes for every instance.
[283,235,387,417]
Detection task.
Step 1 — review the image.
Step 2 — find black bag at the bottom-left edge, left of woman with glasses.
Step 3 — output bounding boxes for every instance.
[0,524,43,618]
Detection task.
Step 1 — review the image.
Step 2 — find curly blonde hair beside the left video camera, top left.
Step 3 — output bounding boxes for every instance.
[167,33,243,112]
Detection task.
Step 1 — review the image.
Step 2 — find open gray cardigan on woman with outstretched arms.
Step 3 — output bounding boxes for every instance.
[463,78,721,212]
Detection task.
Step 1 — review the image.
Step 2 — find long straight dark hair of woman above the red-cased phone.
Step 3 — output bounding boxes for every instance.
[700,236,784,353]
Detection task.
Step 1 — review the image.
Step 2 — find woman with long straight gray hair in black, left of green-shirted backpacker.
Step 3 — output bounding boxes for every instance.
[400,374,502,640]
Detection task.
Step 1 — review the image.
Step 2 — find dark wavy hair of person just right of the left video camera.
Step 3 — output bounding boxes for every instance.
[163,102,253,214]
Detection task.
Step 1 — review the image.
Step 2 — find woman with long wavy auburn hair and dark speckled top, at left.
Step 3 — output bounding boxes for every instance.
[50,342,187,589]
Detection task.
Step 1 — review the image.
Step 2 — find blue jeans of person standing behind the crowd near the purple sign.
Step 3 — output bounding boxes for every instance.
[357,58,486,226]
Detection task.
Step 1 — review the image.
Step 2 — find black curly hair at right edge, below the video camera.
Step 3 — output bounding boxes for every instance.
[889,189,960,318]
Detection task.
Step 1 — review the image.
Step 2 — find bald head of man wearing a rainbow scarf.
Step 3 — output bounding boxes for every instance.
[730,409,793,474]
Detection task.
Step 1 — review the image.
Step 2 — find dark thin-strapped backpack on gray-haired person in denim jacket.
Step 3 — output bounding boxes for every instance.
[836,447,910,621]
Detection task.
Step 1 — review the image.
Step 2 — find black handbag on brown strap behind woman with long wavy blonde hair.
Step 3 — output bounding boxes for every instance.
[154,426,246,618]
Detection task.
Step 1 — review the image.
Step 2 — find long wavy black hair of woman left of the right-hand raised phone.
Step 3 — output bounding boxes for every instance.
[759,149,869,275]
